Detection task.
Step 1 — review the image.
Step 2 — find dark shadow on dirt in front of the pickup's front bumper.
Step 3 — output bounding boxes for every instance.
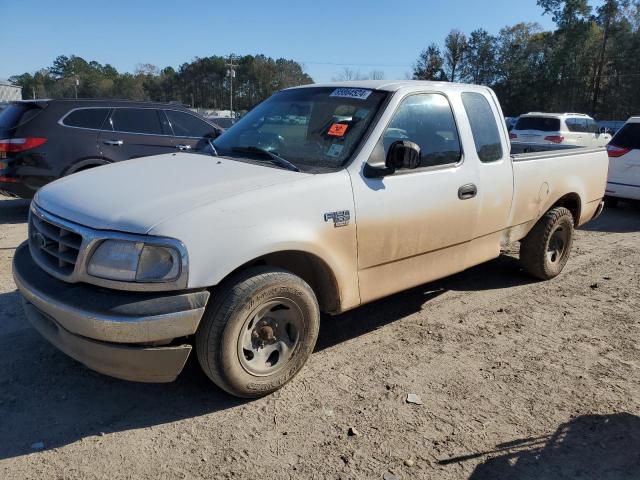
[0,320,243,460]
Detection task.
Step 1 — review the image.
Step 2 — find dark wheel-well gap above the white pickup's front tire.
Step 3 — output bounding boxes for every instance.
[230,250,340,313]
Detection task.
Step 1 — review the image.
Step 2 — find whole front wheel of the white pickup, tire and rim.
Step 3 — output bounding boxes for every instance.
[196,267,320,398]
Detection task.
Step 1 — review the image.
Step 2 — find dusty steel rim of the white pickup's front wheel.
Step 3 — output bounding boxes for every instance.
[238,298,304,377]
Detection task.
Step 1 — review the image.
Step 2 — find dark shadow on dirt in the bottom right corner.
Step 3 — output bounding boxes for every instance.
[440,413,640,480]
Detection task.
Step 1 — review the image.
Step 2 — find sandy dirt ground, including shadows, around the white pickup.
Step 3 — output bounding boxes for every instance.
[0,196,640,480]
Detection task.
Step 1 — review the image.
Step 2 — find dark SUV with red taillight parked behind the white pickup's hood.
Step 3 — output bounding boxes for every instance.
[0,100,222,198]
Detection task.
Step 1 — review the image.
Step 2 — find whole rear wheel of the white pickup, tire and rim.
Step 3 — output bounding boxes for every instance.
[520,207,574,280]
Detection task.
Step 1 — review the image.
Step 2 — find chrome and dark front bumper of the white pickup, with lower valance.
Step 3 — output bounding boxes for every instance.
[13,242,209,382]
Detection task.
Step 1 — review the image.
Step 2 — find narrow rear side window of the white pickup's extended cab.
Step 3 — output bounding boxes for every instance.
[462,93,502,162]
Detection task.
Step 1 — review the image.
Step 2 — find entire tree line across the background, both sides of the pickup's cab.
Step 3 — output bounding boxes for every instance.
[10,0,640,119]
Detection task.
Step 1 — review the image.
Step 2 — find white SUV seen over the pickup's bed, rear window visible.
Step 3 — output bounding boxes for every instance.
[509,112,611,147]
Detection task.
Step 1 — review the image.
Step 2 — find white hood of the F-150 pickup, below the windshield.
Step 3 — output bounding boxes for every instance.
[34,153,309,234]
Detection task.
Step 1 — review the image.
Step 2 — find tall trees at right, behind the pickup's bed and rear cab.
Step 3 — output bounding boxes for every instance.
[413,0,640,120]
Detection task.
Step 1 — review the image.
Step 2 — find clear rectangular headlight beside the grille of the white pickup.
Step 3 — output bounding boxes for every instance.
[87,240,182,282]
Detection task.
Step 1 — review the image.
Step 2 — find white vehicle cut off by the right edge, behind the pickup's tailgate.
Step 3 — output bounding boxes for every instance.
[607,117,640,205]
